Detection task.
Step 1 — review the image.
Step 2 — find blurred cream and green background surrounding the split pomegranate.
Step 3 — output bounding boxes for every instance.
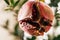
[0,0,60,40]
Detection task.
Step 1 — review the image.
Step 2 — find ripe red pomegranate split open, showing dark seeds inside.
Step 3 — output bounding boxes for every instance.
[18,1,54,36]
